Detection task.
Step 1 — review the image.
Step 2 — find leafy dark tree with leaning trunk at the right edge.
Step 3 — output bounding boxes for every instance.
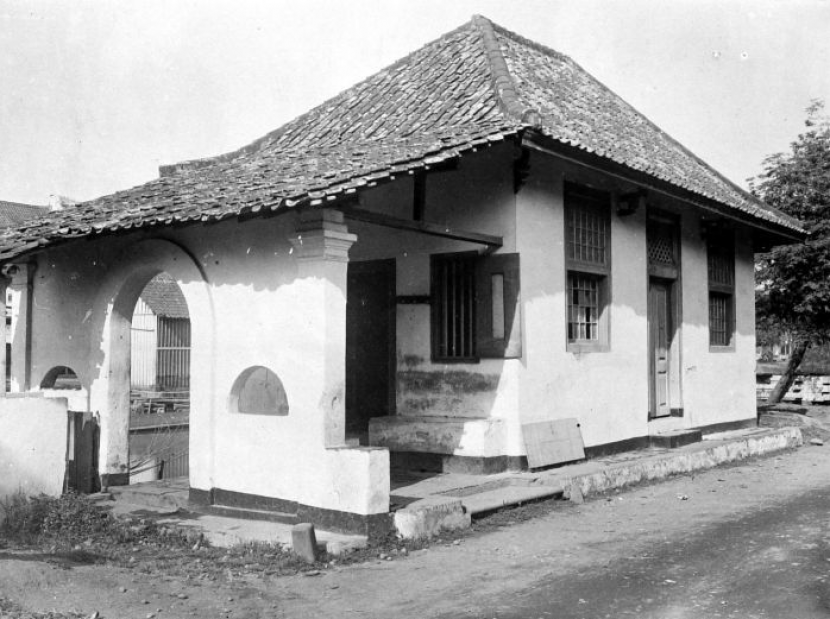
[751,101,830,401]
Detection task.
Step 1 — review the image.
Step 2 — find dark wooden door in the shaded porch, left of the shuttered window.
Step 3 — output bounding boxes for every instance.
[346,260,395,436]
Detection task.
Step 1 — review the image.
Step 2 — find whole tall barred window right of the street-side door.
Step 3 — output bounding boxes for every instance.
[706,230,735,347]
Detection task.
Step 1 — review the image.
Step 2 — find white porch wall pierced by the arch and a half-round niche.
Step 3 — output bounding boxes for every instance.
[20,213,388,514]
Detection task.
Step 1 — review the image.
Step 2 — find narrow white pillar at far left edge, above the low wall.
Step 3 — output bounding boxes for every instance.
[8,262,37,393]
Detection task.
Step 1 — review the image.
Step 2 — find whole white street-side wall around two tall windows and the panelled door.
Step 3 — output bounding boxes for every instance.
[511,153,755,453]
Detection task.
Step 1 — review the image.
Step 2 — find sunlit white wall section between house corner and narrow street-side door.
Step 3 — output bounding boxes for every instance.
[511,153,648,455]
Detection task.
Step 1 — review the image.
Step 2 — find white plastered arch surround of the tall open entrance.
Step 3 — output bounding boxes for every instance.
[90,240,214,487]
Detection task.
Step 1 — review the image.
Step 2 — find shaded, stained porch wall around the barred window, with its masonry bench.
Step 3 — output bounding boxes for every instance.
[356,144,521,456]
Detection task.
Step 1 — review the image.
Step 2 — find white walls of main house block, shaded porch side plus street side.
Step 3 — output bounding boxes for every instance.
[364,146,755,457]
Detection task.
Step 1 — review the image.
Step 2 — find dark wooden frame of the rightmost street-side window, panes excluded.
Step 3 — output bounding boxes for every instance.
[706,228,737,352]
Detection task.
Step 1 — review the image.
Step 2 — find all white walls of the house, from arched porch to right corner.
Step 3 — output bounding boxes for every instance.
[13,144,755,498]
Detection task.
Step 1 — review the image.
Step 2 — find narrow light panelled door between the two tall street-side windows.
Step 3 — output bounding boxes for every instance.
[648,280,672,418]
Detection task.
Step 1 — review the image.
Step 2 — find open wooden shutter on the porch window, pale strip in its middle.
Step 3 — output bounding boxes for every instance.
[476,254,522,359]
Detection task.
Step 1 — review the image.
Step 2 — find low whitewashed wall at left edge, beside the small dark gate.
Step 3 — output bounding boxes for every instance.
[0,394,69,499]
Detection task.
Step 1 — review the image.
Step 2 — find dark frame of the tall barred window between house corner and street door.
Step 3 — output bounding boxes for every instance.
[564,182,612,353]
